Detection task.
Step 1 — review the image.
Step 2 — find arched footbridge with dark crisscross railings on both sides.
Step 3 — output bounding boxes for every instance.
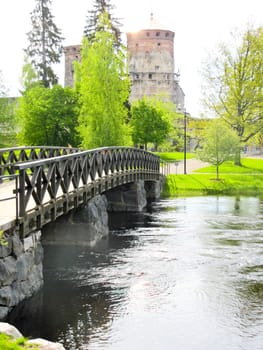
[0,146,165,239]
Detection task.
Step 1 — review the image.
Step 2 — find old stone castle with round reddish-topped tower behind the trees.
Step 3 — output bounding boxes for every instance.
[64,15,184,109]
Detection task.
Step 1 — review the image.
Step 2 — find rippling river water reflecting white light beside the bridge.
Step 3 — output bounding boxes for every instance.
[7,196,263,350]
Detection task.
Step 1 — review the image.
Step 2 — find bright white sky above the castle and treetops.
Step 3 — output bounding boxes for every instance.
[0,0,263,117]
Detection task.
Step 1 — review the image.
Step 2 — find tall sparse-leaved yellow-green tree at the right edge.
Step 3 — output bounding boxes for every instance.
[203,28,263,165]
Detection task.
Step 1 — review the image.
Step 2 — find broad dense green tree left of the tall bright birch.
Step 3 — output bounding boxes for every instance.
[17,85,79,146]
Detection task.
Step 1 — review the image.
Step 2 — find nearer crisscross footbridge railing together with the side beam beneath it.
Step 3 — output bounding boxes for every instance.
[11,147,162,235]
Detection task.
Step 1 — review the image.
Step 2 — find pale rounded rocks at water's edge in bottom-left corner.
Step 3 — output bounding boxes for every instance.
[0,322,65,350]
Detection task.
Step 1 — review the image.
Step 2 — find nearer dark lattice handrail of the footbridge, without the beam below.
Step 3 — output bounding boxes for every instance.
[14,147,160,217]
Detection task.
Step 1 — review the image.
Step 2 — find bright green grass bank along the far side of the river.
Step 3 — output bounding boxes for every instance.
[163,158,263,196]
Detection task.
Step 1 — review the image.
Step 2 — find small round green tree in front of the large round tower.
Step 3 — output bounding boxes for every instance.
[130,98,171,150]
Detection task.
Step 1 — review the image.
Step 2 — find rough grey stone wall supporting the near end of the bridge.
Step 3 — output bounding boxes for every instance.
[0,231,43,319]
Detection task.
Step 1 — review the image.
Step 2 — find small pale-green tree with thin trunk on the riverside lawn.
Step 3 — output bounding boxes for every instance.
[197,119,239,180]
